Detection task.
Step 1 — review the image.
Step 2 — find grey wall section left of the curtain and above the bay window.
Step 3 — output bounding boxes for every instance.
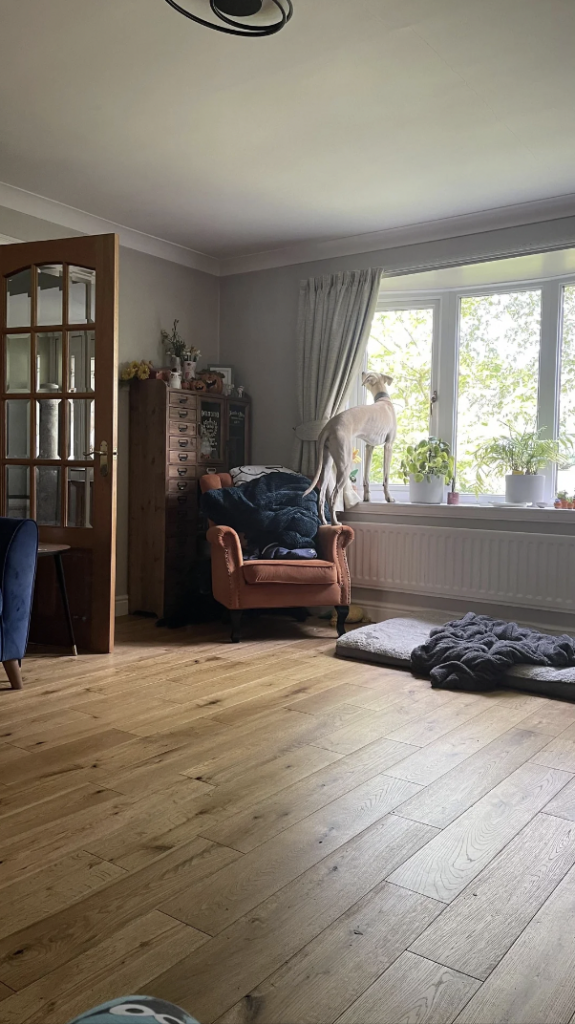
[220,217,575,466]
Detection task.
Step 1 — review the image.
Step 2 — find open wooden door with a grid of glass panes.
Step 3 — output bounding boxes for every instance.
[0,234,118,653]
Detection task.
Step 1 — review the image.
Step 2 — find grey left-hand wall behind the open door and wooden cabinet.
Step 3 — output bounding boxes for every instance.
[0,207,220,596]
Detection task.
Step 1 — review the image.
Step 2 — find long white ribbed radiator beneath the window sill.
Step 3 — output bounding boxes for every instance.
[348,522,575,611]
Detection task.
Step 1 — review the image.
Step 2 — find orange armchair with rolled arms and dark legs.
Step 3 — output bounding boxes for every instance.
[200,473,354,643]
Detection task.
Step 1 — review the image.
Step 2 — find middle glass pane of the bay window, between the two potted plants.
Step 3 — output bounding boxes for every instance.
[456,291,541,495]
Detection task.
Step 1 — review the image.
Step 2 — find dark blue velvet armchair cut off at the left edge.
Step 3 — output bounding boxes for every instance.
[0,517,38,690]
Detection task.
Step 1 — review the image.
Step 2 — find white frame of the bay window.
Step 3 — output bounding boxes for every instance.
[358,274,575,505]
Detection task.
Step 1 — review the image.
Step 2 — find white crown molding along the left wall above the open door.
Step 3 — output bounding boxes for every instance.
[0,182,220,278]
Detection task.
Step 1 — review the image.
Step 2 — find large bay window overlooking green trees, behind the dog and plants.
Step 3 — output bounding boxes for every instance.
[358,268,575,503]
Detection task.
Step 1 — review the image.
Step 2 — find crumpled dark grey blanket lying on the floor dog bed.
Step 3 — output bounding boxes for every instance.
[411,611,575,690]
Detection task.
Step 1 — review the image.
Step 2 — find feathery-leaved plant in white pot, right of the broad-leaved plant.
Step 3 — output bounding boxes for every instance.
[475,424,573,505]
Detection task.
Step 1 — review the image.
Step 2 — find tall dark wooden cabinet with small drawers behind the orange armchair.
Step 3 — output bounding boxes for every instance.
[128,380,251,617]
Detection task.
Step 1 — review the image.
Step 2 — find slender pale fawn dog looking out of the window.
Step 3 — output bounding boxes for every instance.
[304,373,397,524]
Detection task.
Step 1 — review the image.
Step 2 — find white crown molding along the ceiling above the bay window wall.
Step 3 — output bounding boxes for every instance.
[220,194,575,278]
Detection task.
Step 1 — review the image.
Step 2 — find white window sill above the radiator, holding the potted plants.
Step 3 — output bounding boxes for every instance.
[345,501,575,530]
